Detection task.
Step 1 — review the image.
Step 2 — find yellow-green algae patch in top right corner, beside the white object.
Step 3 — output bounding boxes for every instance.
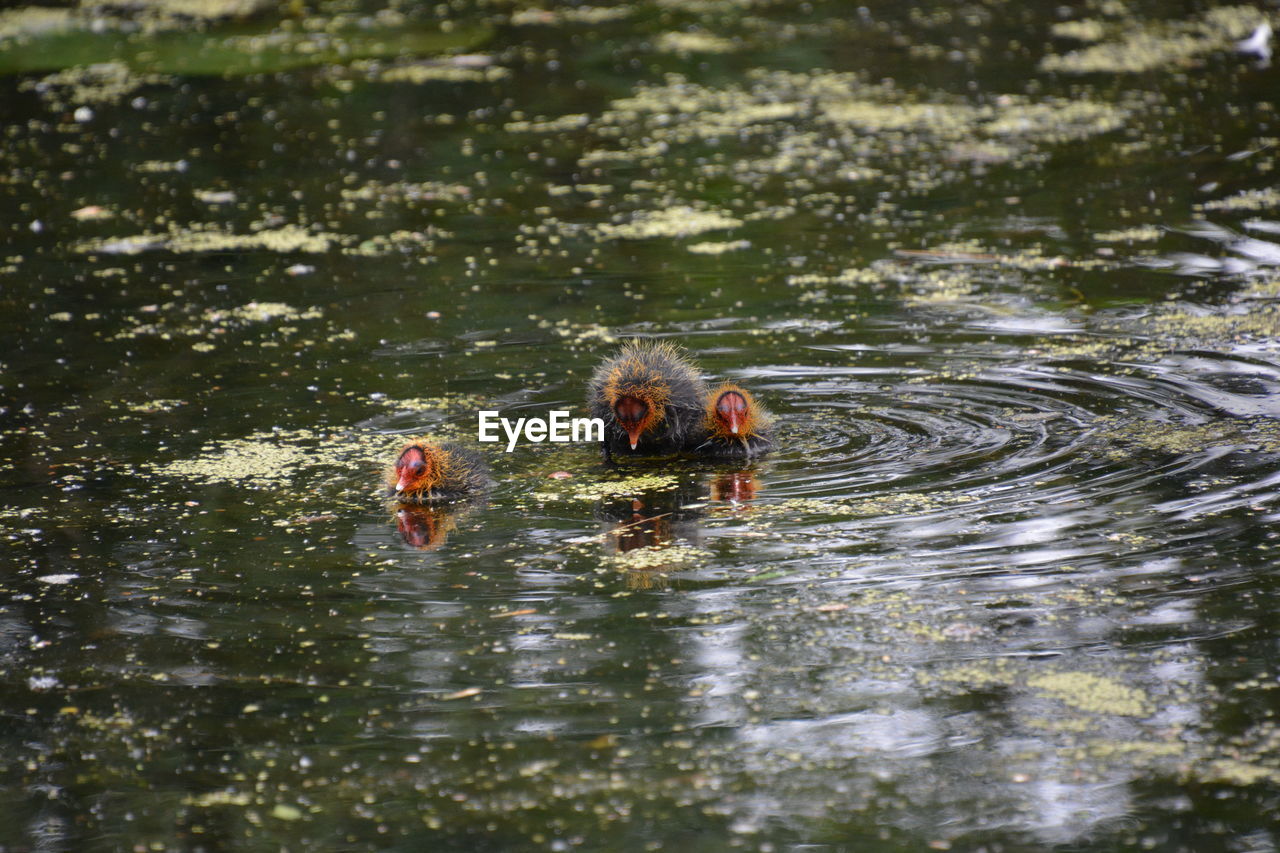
[1041,6,1265,74]
